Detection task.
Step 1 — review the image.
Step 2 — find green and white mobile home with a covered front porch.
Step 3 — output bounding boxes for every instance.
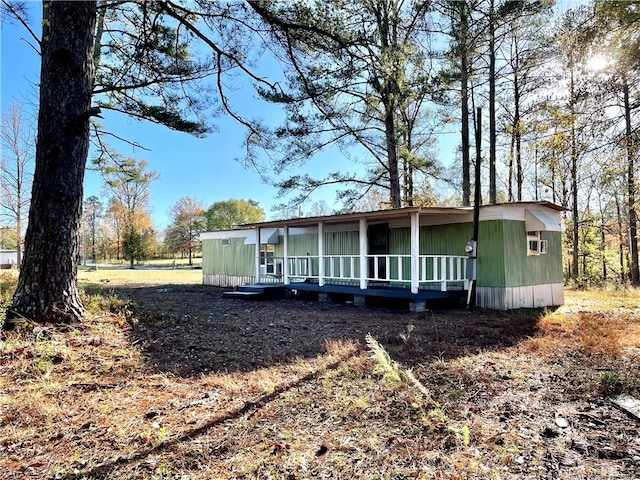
[201,202,564,310]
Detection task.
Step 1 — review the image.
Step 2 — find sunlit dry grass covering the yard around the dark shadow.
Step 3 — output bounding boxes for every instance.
[0,282,640,480]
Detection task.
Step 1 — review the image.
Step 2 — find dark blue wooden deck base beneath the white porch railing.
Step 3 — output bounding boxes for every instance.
[224,282,467,312]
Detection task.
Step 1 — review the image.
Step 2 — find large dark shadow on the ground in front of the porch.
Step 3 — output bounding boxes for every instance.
[114,286,542,377]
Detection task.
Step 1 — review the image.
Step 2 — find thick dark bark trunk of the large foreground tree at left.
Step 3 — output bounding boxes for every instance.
[8,1,96,323]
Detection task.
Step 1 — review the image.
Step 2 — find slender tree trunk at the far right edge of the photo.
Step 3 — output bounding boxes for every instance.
[622,73,640,287]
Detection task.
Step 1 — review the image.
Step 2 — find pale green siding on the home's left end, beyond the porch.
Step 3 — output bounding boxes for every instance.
[202,238,256,276]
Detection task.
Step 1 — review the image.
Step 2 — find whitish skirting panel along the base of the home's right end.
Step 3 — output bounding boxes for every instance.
[476,283,564,310]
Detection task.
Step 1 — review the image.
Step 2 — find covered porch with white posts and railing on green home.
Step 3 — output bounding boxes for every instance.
[249,207,471,303]
